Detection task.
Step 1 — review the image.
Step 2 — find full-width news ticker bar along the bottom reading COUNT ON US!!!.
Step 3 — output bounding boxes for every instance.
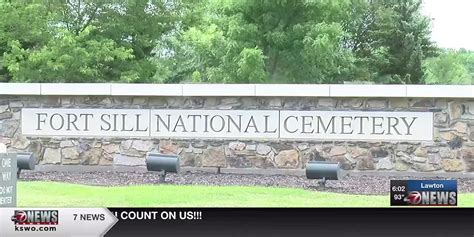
[0,208,474,237]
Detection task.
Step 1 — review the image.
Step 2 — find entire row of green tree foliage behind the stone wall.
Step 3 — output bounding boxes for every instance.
[0,0,462,84]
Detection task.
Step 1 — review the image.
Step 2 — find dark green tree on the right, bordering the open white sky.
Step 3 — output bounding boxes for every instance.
[344,0,437,84]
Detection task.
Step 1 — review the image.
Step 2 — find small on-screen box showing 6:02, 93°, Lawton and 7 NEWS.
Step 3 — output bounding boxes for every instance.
[390,180,458,206]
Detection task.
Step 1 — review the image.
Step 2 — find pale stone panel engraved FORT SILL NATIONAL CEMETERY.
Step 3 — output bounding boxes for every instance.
[21,108,433,141]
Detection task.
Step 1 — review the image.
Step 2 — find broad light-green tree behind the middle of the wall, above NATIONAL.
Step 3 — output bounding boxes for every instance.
[158,0,353,83]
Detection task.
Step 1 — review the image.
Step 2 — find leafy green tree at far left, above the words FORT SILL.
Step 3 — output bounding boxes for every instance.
[0,0,187,82]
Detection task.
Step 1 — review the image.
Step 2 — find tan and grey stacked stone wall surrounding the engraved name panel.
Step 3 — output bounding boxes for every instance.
[0,96,474,172]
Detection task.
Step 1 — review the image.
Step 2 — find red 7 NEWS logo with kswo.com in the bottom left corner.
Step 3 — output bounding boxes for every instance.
[11,210,59,231]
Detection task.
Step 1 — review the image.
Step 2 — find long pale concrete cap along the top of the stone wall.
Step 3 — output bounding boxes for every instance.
[0,83,474,98]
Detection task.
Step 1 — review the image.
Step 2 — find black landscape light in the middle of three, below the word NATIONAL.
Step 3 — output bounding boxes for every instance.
[145,153,179,183]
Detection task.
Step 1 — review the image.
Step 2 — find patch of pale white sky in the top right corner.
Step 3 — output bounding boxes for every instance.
[422,0,474,50]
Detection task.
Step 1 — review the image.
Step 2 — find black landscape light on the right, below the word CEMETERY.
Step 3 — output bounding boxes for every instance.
[306,161,342,186]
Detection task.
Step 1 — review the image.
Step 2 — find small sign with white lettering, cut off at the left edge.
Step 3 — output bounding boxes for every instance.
[0,153,17,207]
